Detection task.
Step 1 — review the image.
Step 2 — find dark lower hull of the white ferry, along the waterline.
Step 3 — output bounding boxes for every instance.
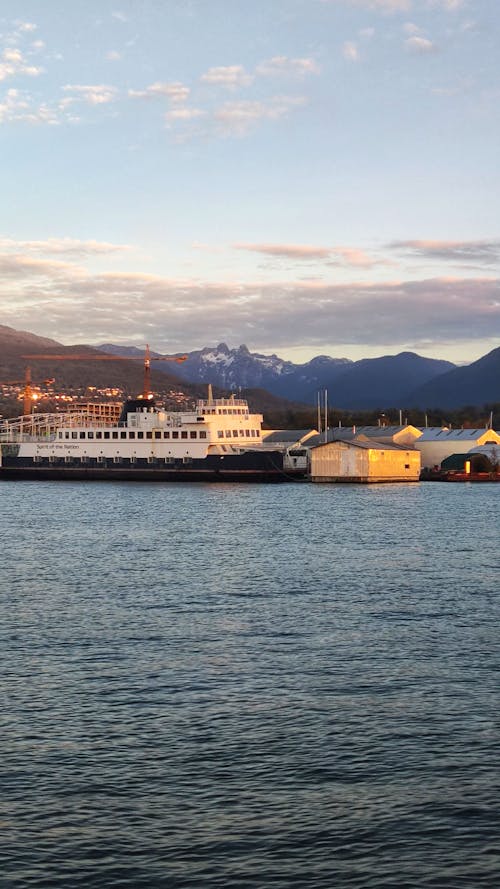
[0,451,301,482]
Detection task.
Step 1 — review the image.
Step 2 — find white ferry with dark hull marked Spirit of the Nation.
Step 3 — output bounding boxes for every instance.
[0,387,299,482]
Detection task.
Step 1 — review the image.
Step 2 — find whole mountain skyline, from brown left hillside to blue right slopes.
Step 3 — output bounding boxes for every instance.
[0,325,500,411]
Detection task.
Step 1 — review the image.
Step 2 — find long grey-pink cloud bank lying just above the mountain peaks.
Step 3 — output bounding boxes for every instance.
[0,256,500,351]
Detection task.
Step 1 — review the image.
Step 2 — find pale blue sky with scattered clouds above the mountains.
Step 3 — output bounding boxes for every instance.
[0,0,500,363]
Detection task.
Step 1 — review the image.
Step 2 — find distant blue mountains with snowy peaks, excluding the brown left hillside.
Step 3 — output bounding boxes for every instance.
[99,343,500,410]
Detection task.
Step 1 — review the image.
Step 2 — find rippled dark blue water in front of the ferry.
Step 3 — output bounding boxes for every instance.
[0,482,500,889]
